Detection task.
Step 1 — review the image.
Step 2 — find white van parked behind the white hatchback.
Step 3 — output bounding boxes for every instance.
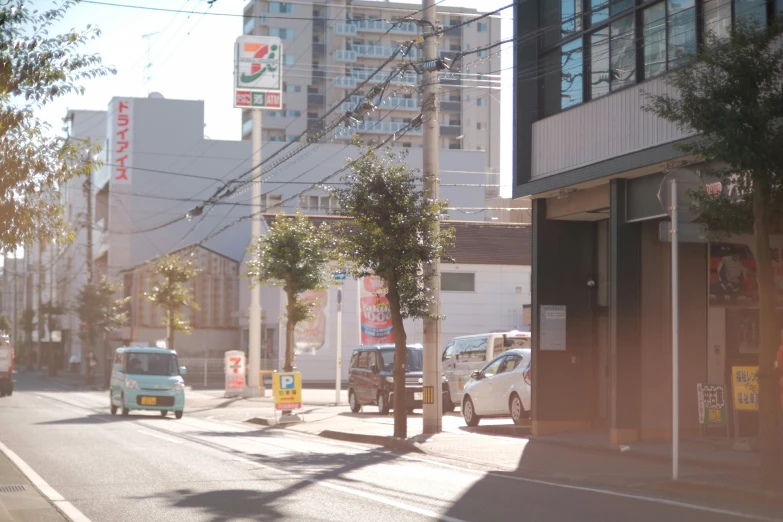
[441,330,530,404]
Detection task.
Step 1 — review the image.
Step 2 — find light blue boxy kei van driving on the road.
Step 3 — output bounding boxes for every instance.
[109,346,186,419]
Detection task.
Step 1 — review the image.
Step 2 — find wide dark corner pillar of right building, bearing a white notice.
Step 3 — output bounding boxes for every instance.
[531,199,597,435]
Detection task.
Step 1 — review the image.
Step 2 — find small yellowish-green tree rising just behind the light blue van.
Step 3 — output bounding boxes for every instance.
[144,253,200,350]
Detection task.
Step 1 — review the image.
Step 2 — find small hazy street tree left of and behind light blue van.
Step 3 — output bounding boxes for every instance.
[73,276,130,363]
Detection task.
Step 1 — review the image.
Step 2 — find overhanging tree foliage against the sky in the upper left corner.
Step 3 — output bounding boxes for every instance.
[0,0,114,251]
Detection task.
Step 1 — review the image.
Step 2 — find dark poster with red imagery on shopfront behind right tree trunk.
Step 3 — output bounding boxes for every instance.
[709,236,783,307]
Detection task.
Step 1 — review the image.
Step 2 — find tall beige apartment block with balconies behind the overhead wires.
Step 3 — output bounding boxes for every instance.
[242,0,500,189]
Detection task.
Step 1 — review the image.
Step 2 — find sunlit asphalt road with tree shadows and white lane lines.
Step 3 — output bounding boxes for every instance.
[0,377,783,522]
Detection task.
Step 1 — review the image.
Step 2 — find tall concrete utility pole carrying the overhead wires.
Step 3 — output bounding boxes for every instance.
[421,0,443,433]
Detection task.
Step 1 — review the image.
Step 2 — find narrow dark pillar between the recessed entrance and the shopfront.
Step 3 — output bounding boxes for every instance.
[609,179,643,444]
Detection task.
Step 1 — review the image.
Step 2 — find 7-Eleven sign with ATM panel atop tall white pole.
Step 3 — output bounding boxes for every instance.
[234,35,283,109]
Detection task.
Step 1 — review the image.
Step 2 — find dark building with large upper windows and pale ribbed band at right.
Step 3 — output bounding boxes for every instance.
[514,0,783,444]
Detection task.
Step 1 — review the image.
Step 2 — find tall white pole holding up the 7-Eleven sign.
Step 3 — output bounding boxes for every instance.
[245,109,262,397]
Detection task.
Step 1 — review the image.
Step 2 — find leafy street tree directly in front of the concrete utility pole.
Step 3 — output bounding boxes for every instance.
[333,146,453,438]
